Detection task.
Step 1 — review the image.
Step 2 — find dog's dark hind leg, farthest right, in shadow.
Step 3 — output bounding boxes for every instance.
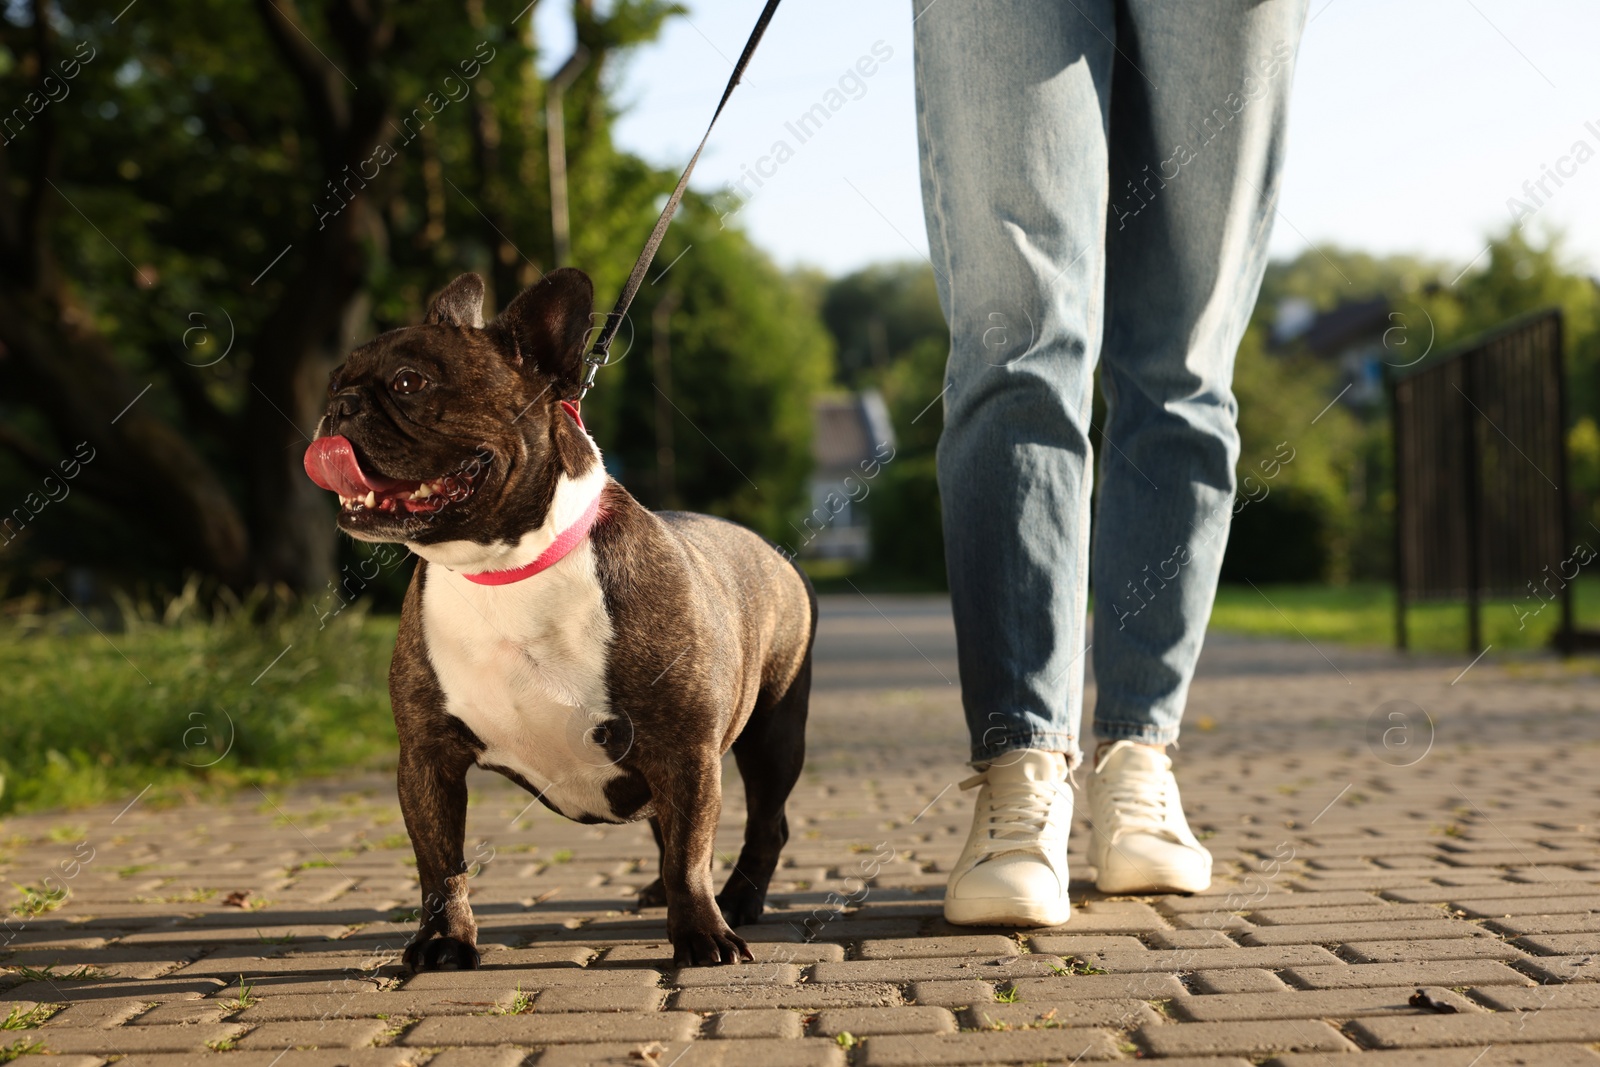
[717,656,811,926]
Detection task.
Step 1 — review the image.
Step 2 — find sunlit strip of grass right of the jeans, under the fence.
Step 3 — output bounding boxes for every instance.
[1211,577,1600,653]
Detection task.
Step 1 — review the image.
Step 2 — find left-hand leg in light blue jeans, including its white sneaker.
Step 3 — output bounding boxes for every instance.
[914,0,1112,925]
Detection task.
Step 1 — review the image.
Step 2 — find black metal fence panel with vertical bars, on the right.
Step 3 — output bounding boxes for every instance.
[1390,309,1573,654]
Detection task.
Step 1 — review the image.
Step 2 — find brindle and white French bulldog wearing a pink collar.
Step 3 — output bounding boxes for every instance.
[306,269,816,971]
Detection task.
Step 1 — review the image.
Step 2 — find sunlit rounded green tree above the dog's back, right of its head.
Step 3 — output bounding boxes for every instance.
[584,198,832,541]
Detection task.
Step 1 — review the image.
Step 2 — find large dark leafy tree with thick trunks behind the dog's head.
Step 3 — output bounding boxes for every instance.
[0,0,726,592]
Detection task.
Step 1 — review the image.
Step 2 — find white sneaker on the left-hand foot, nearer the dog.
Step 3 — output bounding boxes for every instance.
[944,749,1072,926]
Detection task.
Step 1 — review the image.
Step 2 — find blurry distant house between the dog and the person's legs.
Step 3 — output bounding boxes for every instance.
[797,389,894,561]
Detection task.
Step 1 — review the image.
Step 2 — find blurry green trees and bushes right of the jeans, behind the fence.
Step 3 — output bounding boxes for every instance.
[1222,223,1600,582]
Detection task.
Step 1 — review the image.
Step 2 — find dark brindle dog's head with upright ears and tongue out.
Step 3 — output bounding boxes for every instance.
[306,267,598,544]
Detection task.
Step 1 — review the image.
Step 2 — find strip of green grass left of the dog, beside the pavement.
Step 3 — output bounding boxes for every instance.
[0,597,397,819]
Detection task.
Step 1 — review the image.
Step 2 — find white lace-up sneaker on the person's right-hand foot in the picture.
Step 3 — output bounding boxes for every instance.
[1088,741,1211,893]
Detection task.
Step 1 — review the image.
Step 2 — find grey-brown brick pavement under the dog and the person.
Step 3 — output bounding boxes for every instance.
[0,597,1600,1067]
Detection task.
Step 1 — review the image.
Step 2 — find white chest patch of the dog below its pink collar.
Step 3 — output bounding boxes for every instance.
[422,542,621,821]
